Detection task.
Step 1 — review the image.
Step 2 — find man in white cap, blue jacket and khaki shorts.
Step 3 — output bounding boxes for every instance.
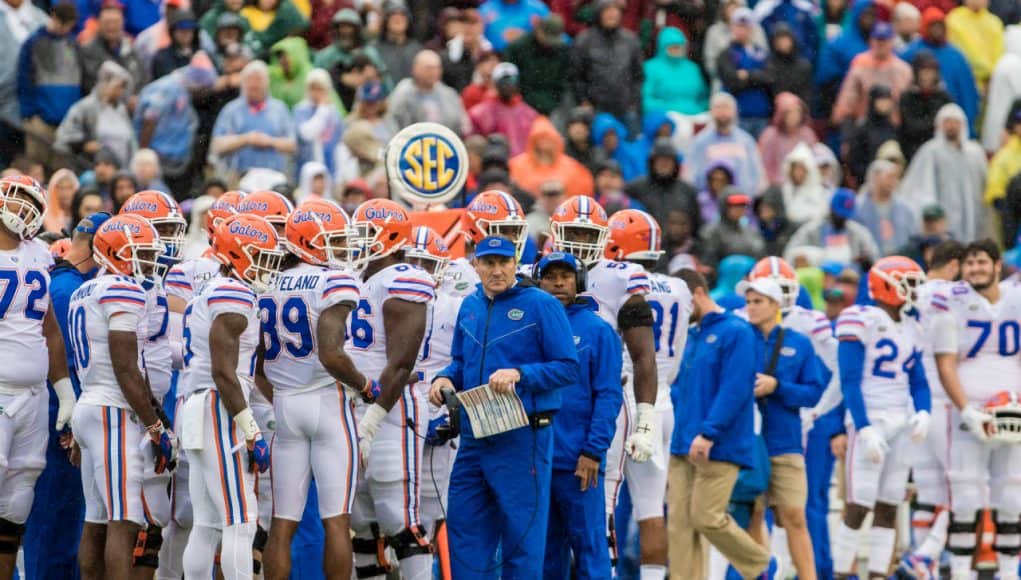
[737,278,825,580]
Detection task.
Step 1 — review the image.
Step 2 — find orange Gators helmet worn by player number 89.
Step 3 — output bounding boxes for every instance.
[285,198,354,268]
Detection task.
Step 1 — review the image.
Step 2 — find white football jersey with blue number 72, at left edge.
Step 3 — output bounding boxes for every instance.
[0,240,53,394]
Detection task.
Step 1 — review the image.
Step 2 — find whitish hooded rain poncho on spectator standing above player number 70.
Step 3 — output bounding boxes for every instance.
[901,103,985,242]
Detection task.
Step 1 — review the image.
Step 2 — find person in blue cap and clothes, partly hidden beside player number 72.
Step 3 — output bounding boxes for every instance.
[23,211,110,580]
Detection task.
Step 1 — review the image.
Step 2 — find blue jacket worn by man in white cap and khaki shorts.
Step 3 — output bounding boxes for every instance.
[756,326,826,457]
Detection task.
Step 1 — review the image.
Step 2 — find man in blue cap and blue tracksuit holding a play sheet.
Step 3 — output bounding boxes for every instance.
[430,237,579,580]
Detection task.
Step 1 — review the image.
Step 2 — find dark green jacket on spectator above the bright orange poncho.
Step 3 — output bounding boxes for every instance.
[505,34,571,115]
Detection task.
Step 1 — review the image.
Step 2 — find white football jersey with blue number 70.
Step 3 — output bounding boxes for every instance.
[932,282,1021,404]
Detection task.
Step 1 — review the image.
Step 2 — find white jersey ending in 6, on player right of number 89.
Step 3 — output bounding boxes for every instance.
[347,263,436,380]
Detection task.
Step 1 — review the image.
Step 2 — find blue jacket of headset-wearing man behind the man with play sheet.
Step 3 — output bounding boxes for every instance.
[553,298,624,472]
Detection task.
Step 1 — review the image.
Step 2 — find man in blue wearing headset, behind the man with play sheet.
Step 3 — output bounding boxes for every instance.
[532,252,624,580]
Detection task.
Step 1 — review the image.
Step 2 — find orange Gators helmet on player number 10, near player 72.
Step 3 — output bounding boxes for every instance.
[92,213,166,286]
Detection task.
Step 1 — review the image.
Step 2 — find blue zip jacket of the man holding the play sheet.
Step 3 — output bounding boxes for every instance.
[438,284,579,438]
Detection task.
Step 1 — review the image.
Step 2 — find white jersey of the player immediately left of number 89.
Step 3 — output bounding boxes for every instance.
[180,276,259,400]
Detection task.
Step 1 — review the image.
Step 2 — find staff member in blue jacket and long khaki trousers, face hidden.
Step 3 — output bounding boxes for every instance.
[668,270,770,578]
